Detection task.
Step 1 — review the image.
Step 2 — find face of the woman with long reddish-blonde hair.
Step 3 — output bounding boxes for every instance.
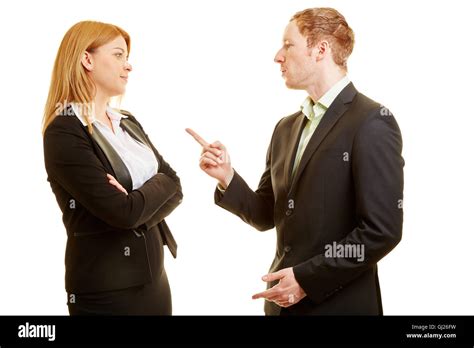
[82,36,132,97]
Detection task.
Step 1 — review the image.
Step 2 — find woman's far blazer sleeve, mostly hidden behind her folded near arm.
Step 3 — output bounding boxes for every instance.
[130,115,183,230]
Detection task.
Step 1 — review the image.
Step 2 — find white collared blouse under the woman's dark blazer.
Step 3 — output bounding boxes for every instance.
[71,104,158,190]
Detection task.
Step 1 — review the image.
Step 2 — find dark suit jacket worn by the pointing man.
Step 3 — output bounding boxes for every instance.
[215,83,404,315]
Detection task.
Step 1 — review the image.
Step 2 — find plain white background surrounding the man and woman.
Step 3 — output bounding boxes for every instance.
[0,0,474,315]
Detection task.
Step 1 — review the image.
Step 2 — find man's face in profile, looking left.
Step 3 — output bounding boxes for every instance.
[274,21,317,90]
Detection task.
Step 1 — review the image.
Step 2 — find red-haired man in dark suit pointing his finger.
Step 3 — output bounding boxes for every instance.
[187,8,404,315]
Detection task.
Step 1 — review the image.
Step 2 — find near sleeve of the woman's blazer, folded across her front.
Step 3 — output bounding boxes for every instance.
[43,116,178,229]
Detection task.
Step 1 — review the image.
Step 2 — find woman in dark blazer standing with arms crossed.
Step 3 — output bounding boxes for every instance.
[43,21,182,315]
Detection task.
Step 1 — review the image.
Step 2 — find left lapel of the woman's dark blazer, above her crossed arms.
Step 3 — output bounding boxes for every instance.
[91,124,133,192]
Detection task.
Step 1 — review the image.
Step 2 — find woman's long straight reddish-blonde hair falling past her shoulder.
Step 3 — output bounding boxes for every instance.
[42,21,130,135]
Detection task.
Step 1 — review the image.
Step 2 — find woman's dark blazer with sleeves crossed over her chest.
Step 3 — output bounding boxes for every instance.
[43,108,183,294]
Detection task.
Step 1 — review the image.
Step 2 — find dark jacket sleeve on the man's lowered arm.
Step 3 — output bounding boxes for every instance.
[293,110,404,303]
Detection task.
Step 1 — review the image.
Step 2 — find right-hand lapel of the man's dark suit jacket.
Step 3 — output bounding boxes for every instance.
[290,82,357,191]
